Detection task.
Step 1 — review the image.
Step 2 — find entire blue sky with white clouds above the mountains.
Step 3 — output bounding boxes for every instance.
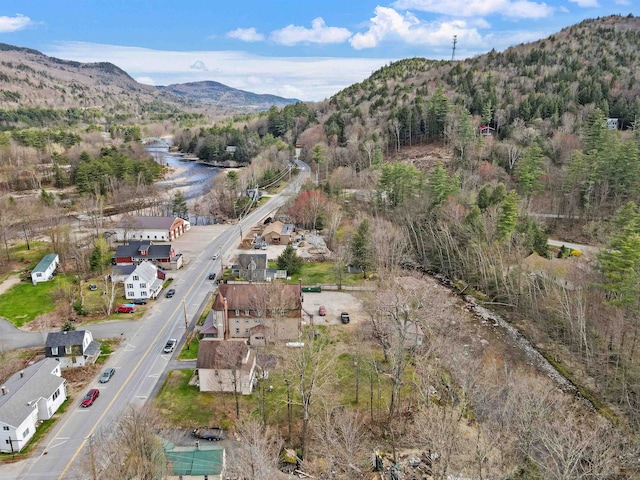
[0,0,640,101]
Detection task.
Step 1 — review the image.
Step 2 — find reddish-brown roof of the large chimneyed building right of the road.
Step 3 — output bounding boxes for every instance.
[213,283,301,311]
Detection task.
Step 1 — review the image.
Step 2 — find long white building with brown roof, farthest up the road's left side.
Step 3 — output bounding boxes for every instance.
[114,215,191,242]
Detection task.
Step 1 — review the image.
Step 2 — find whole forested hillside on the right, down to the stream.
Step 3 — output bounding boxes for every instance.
[276,16,640,458]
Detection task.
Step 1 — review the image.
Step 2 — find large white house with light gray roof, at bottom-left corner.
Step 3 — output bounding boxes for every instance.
[0,358,67,453]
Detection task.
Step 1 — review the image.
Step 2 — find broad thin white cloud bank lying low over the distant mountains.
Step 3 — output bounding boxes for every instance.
[43,42,390,101]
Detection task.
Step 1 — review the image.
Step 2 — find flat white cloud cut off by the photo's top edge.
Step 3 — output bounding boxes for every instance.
[393,0,556,18]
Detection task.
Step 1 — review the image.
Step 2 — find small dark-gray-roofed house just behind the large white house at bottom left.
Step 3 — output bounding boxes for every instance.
[44,330,100,368]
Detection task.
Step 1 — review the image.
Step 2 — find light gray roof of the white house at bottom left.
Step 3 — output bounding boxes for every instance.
[0,358,65,427]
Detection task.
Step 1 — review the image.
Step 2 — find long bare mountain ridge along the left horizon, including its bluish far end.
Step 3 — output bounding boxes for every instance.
[0,43,297,126]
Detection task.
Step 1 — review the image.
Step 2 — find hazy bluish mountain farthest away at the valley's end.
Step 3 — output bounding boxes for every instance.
[158,81,300,111]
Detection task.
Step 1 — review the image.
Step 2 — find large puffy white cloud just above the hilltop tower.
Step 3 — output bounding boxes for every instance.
[350,6,482,50]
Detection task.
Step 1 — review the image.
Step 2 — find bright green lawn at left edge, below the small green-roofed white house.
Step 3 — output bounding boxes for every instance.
[0,275,74,327]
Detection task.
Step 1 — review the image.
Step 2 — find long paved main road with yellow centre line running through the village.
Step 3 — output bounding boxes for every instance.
[0,162,309,480]
